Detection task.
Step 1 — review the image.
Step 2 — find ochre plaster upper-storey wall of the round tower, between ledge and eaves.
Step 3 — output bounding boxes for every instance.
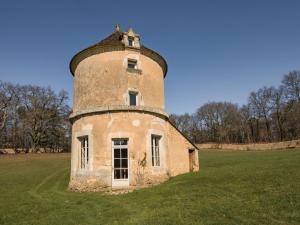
[73,50,165,112]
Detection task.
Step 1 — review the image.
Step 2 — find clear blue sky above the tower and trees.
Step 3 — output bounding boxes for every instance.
[0,0,300,113]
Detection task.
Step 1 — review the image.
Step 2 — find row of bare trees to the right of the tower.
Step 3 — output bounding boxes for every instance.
[170,71,300,143]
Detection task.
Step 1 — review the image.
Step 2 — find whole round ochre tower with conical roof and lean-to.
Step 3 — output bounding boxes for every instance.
[69,25,199,190]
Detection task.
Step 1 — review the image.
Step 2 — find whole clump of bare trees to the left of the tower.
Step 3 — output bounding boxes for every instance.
[0,81,71,152]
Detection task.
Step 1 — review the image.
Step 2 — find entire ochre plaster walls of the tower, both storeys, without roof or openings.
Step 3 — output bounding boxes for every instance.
[69,40,199,191]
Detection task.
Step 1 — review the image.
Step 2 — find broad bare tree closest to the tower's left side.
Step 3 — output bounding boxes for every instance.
[20,85,69,151]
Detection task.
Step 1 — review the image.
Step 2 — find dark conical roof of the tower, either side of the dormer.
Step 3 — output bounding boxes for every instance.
[70,30,168,76]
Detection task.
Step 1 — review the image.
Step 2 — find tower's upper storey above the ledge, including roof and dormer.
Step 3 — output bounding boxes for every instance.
[70,26,167,112]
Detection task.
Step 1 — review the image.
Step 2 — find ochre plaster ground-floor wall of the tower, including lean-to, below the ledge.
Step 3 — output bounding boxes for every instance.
[70,112,199,190]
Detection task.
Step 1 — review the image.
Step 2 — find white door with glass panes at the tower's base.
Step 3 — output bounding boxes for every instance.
[112,139,129,187]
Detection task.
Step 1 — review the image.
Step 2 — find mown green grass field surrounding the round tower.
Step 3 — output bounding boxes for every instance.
[0,149,300,225]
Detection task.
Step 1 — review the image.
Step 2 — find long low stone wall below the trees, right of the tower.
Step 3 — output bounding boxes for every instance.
[197,140,300,151]
